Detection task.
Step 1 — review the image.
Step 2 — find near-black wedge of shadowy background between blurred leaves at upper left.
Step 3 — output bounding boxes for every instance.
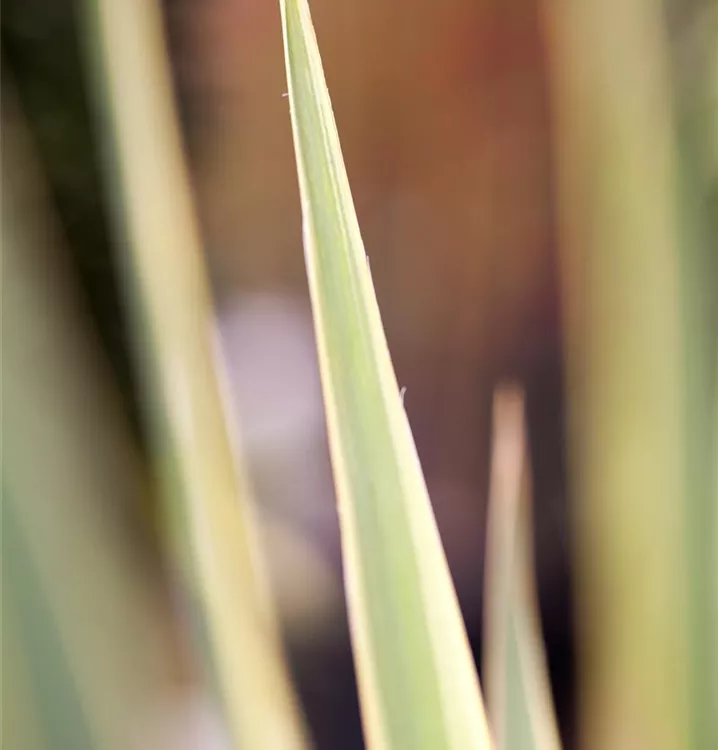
[0,0,139,436]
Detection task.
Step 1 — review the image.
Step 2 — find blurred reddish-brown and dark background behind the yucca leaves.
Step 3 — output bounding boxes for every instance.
[0,0,718,750]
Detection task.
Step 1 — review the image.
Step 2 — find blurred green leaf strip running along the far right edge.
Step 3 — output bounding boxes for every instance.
[671,8,718,749]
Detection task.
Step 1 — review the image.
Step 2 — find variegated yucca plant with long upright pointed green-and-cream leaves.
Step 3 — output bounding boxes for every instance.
[2,0,718,750]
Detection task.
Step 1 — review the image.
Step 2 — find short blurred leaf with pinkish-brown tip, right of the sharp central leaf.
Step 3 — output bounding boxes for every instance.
[483,386,561,750]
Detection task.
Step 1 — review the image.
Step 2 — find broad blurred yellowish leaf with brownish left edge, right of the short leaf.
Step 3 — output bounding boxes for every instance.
[544,0,690,750]
